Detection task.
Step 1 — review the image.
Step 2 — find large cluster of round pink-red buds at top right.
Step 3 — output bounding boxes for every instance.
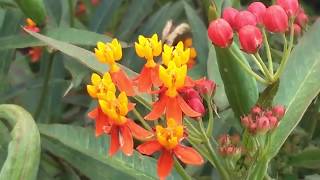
[208,0,308,54]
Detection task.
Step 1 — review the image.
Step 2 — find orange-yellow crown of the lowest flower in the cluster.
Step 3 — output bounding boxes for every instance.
[156,118,183,150]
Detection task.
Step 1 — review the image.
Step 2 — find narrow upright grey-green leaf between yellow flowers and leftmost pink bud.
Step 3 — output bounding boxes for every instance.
[184,2,209,78]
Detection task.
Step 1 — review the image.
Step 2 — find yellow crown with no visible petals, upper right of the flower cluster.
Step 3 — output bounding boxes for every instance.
[162,41,190,67]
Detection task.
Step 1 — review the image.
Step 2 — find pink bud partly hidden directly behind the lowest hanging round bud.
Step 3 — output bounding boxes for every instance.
[234,11,257,31]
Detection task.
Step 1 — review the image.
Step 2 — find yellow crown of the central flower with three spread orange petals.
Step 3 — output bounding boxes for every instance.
[159,61,187,97]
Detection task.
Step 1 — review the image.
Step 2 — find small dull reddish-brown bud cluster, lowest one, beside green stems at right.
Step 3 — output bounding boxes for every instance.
[218,134,242,157]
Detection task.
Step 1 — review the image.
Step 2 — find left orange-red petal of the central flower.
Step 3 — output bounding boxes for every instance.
[144,96,168,120]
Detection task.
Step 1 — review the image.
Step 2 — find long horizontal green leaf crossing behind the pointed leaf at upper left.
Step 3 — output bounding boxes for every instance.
[0,28,128,50]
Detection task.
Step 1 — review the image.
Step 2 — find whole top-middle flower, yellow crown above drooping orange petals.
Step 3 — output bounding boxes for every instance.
[135,34,162,92]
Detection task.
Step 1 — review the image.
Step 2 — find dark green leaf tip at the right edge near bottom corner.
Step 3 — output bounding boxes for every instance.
[288,148,320,169]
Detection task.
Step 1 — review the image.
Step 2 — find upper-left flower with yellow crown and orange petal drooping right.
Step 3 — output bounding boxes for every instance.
[94,39,135,96]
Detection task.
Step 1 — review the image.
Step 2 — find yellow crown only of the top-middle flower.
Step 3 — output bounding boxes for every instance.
[134,34,162,67]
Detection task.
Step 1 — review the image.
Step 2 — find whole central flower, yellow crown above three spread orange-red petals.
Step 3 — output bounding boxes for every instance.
[145,61,201,124]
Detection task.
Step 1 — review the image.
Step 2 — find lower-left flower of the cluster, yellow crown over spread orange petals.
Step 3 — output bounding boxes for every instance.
[88,91,153,156]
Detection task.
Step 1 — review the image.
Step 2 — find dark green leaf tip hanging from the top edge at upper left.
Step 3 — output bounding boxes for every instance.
[15,0,46,24]
